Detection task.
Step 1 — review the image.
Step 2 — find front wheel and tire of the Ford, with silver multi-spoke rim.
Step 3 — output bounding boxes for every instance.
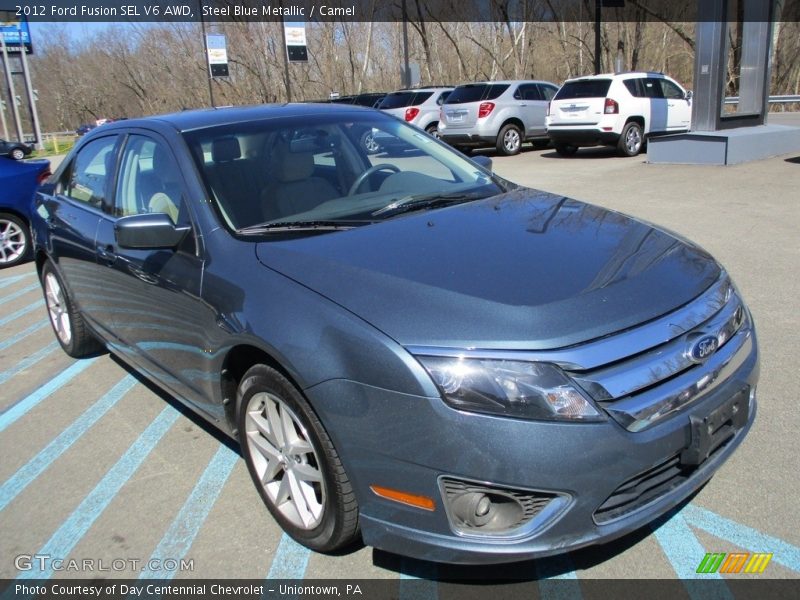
[237,365,359,552]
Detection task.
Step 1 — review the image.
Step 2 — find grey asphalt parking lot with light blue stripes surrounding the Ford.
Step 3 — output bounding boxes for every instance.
[0,124,800,588]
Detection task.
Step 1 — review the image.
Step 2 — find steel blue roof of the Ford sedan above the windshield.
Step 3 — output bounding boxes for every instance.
[92,103,380,131]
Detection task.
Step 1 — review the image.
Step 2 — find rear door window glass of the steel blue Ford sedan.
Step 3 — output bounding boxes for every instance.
[62,135,117,208]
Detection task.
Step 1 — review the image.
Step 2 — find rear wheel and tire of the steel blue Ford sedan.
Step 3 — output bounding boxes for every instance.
[42,261,103,358]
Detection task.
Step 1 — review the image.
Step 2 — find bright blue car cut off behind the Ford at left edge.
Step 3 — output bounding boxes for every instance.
[0,157,50,269]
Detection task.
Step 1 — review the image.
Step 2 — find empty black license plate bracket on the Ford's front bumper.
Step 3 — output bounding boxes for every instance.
[680,388,750,467]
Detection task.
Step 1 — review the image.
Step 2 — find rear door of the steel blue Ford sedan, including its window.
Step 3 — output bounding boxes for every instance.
[42,135,119,333]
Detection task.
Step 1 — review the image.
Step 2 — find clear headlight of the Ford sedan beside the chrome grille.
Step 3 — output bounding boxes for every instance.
[417,356,603,421]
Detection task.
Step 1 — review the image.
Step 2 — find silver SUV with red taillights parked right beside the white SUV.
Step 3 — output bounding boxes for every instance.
[439,81,558,156]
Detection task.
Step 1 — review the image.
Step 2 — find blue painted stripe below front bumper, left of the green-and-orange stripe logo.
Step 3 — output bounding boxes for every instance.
[653,513,733,600]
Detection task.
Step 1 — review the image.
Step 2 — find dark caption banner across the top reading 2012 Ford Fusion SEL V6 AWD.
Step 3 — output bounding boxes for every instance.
[0,0,800,23]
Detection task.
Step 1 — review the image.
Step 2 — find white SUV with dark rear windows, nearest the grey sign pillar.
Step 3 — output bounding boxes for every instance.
[547,73,692,156]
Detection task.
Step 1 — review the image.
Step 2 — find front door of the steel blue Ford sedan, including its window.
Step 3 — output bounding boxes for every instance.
[97,132,216,413]
